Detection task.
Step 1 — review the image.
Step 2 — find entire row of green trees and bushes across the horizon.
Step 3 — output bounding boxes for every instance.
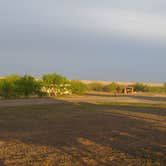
[0,73,166,98]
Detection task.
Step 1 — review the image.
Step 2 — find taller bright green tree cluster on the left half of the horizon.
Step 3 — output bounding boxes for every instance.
[0,73,86,98]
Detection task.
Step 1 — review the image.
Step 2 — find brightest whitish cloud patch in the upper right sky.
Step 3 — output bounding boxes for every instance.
[52,9,166,41]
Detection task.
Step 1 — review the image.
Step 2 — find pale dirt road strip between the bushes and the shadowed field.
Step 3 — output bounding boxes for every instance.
[0,92,166,107]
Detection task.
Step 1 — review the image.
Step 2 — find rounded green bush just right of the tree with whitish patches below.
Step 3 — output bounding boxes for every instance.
[70,81,87,95]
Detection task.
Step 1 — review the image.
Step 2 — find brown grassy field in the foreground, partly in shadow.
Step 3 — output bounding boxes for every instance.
[0,96,166,166]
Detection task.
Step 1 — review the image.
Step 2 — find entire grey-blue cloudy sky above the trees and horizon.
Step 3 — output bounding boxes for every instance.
[0,0,166,82]
